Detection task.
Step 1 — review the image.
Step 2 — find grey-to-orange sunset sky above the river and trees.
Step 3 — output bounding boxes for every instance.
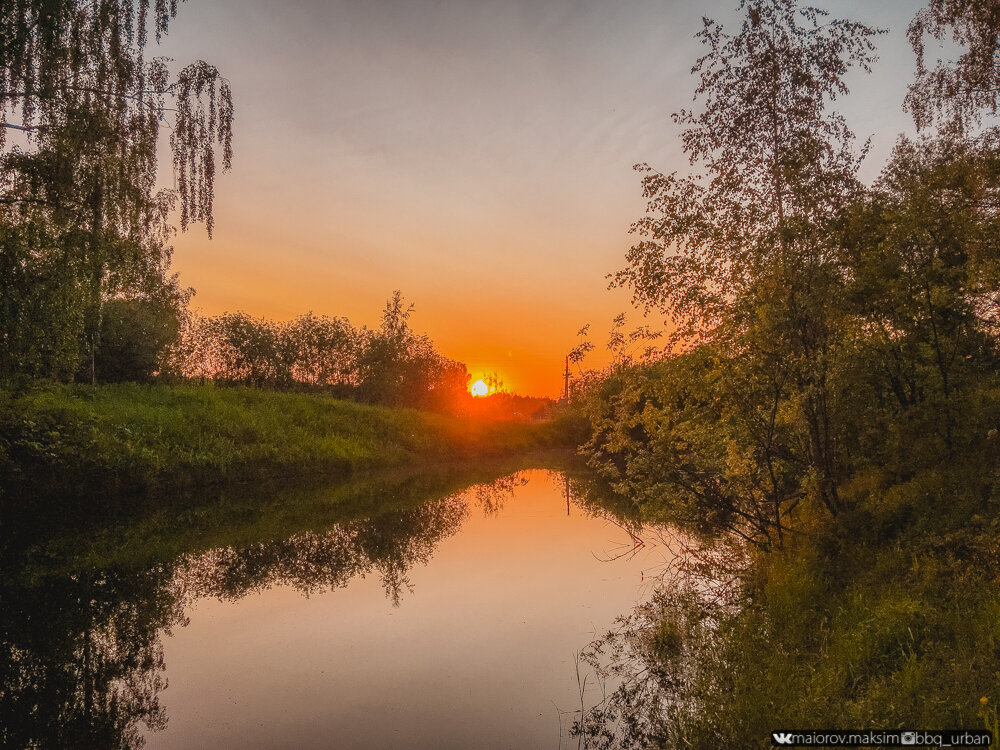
[154,0,923,395]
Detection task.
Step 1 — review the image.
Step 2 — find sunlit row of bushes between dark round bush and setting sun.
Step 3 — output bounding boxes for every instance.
[163,291,469,409]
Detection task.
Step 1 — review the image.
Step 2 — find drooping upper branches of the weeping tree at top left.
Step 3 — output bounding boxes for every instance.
[0,0,233,234]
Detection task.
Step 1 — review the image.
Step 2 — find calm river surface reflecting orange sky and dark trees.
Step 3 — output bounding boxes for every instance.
[0,470,670,749]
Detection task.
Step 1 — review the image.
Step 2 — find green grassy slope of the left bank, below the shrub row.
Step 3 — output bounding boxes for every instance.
[0,385,573,502]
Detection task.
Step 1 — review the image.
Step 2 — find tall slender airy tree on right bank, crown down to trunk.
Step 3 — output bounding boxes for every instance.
[613,0,878,512]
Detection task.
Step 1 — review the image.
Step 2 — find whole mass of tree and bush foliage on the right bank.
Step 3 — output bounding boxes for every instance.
[580,0,1000,546]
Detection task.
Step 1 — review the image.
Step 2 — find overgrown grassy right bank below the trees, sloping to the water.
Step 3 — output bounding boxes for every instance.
[580,442,1000,750]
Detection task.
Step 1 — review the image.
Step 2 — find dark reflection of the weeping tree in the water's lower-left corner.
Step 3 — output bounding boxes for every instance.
[0,569,176,748]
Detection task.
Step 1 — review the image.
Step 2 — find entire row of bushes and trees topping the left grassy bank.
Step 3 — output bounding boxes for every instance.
[0,279,470,413]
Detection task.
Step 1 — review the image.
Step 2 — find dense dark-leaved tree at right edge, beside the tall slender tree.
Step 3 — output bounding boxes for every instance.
[843,132,1000,451]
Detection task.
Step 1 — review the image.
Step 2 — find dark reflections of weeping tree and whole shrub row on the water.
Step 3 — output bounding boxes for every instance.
[0,473,656,748]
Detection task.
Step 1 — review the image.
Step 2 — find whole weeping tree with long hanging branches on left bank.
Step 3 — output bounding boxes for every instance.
[0,0,233,379]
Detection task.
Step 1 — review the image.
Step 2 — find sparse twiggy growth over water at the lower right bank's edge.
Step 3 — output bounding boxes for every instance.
[560,526,749,750]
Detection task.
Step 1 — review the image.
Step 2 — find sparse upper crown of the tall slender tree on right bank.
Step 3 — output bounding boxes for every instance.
[614,0,876,338]
